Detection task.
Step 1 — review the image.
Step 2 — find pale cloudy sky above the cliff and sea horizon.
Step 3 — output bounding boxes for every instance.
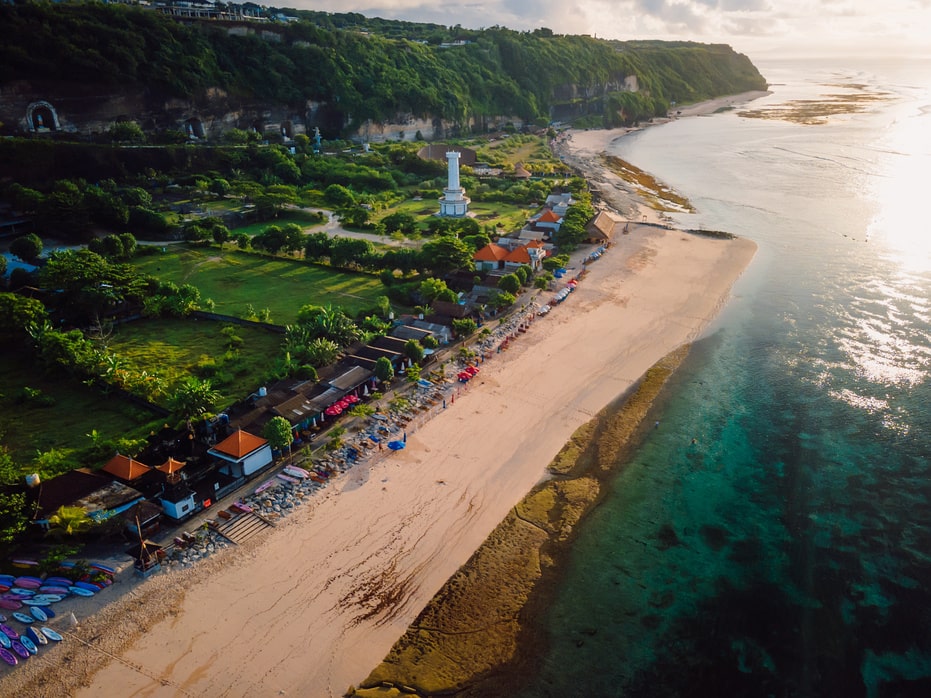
[281,0,931,59]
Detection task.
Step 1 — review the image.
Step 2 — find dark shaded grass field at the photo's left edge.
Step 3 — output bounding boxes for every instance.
[0,354,156,465]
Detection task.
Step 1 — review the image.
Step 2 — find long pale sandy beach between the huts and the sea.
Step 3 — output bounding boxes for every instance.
[0,97,756,697]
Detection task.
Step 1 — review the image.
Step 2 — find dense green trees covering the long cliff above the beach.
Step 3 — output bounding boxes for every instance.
[0,2,765,132]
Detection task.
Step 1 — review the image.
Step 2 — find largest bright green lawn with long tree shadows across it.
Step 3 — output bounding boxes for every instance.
[134,245,385,325]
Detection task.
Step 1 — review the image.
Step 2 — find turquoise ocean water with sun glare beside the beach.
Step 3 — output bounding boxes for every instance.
[526,60,931,698]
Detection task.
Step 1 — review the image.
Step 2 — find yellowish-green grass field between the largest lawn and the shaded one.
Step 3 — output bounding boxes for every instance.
[108,318,284,409]
